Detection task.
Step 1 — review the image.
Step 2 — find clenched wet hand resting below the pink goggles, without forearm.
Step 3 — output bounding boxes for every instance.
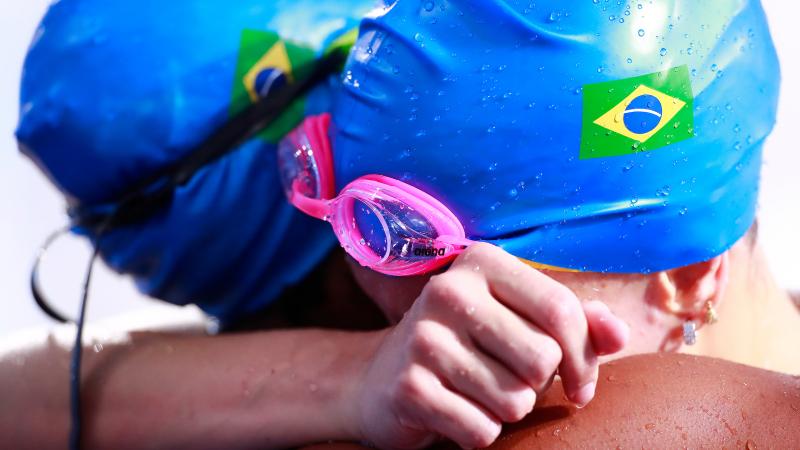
[356,244,628,448]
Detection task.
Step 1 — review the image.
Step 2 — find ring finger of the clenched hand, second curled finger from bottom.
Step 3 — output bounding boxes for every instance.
[418,323,546,422]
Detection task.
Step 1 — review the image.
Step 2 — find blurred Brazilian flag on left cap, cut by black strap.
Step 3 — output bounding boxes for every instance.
[230,30,315,143]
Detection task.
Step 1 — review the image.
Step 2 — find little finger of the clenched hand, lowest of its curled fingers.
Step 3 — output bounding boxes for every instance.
[400,366,502,448]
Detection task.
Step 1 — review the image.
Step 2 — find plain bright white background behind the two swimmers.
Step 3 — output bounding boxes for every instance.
[0,0,800,336]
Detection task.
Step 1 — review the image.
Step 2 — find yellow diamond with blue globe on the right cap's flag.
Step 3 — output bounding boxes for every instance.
[594,85,686,142]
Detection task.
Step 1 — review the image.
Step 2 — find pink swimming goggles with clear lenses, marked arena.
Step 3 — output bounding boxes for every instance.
[278,114,474,276]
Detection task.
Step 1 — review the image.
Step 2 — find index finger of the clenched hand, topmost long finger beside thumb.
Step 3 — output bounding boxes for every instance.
[453,244,598,406]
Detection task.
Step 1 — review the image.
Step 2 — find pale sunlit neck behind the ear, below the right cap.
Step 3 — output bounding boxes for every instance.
[683,242,800,374]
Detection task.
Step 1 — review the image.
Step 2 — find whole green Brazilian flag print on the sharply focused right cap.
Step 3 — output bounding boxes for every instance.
[580,66,694,159]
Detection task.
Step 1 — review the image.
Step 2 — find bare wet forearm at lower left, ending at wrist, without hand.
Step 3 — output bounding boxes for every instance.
[0,330,381,448]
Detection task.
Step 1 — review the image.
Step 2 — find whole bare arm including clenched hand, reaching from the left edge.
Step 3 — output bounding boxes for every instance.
[0,245,627,448]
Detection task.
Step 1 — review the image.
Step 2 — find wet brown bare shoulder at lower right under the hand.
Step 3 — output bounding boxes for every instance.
[476,354,800,449]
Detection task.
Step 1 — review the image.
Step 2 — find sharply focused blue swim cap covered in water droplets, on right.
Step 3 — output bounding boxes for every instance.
[333,0,779,273]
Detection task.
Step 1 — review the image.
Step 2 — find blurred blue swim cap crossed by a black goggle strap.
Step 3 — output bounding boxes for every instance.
[17,0,382,320]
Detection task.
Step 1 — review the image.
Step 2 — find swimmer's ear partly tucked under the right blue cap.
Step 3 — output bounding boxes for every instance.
[648,252,730,320]
